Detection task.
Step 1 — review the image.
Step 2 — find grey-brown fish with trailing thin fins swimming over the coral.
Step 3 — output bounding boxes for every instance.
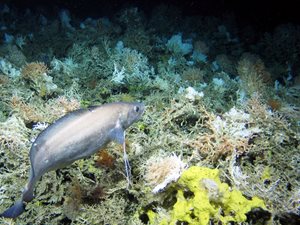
[0,102,145,218]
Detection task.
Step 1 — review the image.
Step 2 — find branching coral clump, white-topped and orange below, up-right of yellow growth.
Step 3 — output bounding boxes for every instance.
[188,108,260,161]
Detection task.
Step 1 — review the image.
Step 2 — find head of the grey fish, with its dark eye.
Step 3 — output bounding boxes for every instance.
[120,102,145,129]
